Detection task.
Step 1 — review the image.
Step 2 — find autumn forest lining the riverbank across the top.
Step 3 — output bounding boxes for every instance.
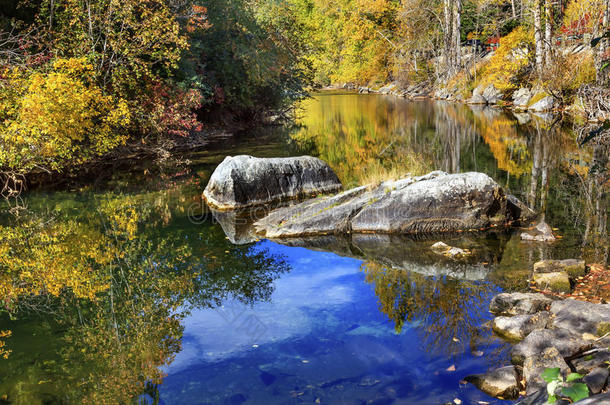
[0,0,610,195]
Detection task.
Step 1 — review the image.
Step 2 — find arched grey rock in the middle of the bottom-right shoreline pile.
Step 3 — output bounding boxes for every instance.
[511,328,593,365]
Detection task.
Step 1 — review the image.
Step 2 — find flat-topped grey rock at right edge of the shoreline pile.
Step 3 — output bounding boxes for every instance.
[550,299,610,336]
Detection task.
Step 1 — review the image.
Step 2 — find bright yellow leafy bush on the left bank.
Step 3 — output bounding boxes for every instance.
[0,58,130,170]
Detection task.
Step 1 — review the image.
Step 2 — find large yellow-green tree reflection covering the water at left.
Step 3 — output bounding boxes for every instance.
[0,191,289,404]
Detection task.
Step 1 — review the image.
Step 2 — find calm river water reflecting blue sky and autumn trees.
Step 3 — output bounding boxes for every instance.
[0,94,608,404]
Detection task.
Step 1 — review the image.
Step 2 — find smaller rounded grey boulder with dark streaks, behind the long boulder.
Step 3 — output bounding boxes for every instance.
[203,155,342,210]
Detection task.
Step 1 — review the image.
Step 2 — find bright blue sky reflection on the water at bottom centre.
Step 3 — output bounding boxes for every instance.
[159,242,503,404]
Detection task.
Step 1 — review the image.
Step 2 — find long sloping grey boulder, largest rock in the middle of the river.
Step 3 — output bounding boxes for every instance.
[254,172,525,239]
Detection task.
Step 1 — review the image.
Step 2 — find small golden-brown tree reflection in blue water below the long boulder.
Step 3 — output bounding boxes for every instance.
[362,261,502,361]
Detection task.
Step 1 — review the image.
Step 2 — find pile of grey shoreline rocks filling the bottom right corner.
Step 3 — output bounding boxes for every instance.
[465,293,610,405]
